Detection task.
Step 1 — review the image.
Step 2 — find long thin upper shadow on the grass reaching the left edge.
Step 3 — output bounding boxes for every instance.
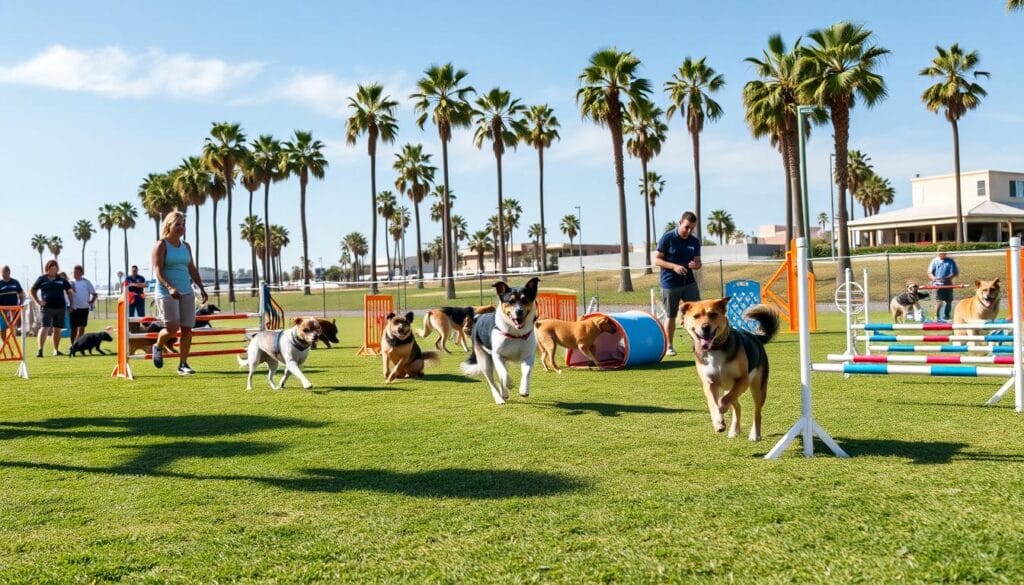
[0,414,324,440]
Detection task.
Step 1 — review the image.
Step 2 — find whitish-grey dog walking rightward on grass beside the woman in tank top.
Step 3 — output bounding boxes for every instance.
[238,317,319,390]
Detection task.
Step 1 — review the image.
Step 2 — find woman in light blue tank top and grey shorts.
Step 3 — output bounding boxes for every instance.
[153,211,208,376]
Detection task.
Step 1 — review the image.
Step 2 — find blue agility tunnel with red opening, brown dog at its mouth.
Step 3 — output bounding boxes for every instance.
[565,310,669,370]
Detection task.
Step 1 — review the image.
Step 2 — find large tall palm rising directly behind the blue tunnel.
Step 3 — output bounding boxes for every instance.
[577,48,650,292]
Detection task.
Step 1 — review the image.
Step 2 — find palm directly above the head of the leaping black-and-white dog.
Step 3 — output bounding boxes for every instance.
[473,87,526,274]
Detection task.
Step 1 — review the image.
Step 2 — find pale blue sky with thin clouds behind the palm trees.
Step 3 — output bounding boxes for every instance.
[0,0,1024,282]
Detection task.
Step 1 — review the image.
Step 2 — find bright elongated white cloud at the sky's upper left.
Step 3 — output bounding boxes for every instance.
[0,45,263,97]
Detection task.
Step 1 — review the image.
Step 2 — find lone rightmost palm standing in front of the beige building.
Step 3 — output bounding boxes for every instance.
[921,43,989,244]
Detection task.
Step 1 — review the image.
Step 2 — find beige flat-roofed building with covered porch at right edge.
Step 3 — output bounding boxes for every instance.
[849,170,1024,245]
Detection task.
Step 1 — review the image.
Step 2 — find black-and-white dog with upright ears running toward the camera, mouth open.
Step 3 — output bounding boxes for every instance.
[462,278,541,405]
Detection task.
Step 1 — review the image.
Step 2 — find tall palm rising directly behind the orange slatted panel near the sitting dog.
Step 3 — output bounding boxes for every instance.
[345,83,398,294]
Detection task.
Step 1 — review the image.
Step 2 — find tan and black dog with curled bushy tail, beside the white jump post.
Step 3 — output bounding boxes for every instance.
[679,297,778,441]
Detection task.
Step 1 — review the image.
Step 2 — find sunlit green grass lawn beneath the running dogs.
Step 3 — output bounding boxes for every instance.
[0,311,1024,583]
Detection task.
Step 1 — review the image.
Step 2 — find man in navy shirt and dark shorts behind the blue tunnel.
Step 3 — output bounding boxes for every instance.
[654,211,701,356]
